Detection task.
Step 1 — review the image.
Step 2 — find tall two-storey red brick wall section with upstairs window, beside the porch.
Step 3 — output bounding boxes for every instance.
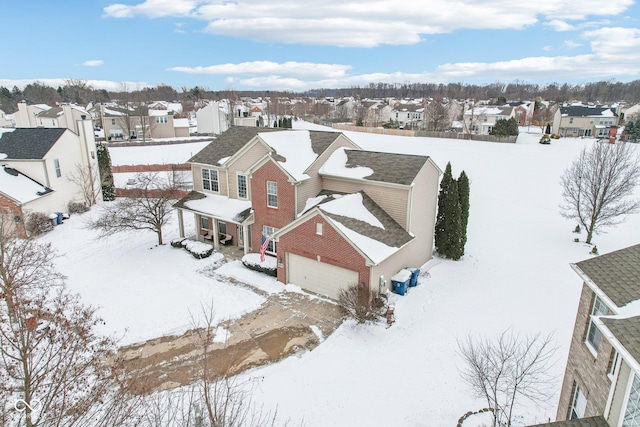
[250,161,296,249]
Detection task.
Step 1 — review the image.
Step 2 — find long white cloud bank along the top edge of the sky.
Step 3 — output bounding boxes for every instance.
[104,0,633,47]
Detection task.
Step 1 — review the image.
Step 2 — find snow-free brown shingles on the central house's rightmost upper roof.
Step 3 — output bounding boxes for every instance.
[344,150,429,185]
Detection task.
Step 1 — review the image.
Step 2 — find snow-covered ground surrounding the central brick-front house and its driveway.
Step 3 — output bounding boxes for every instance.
[44,122,640,427]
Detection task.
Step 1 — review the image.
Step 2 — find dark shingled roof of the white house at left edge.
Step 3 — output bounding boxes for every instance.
[0,128,67,160]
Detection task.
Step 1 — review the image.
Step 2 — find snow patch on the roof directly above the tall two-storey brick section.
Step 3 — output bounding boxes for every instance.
[258,130,318,181]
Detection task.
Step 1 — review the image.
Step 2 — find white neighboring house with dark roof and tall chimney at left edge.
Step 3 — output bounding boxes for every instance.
[0,120,102,234]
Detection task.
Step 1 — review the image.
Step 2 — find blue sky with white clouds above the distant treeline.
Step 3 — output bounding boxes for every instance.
[0,0,640,91]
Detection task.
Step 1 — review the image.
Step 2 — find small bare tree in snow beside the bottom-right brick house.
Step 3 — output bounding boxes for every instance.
[458,331,555,427]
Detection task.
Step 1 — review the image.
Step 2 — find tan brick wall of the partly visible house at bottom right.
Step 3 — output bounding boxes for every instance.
[556,284,613,421]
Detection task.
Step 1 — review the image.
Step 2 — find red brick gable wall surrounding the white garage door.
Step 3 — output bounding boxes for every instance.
[276,215,370,288]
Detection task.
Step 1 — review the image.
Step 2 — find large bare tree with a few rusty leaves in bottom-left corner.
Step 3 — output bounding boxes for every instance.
[0,215,139,427]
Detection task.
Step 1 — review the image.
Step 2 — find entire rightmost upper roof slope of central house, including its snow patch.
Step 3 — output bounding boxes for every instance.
[320,148,429,185]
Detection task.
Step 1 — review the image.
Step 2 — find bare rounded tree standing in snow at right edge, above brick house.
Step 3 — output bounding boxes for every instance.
[560,142,640,244]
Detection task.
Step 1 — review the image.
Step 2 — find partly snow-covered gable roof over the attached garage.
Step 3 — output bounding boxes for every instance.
[276,190,413,264]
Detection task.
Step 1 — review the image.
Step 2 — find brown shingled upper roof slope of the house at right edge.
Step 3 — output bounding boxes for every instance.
[574,244,640,307]
